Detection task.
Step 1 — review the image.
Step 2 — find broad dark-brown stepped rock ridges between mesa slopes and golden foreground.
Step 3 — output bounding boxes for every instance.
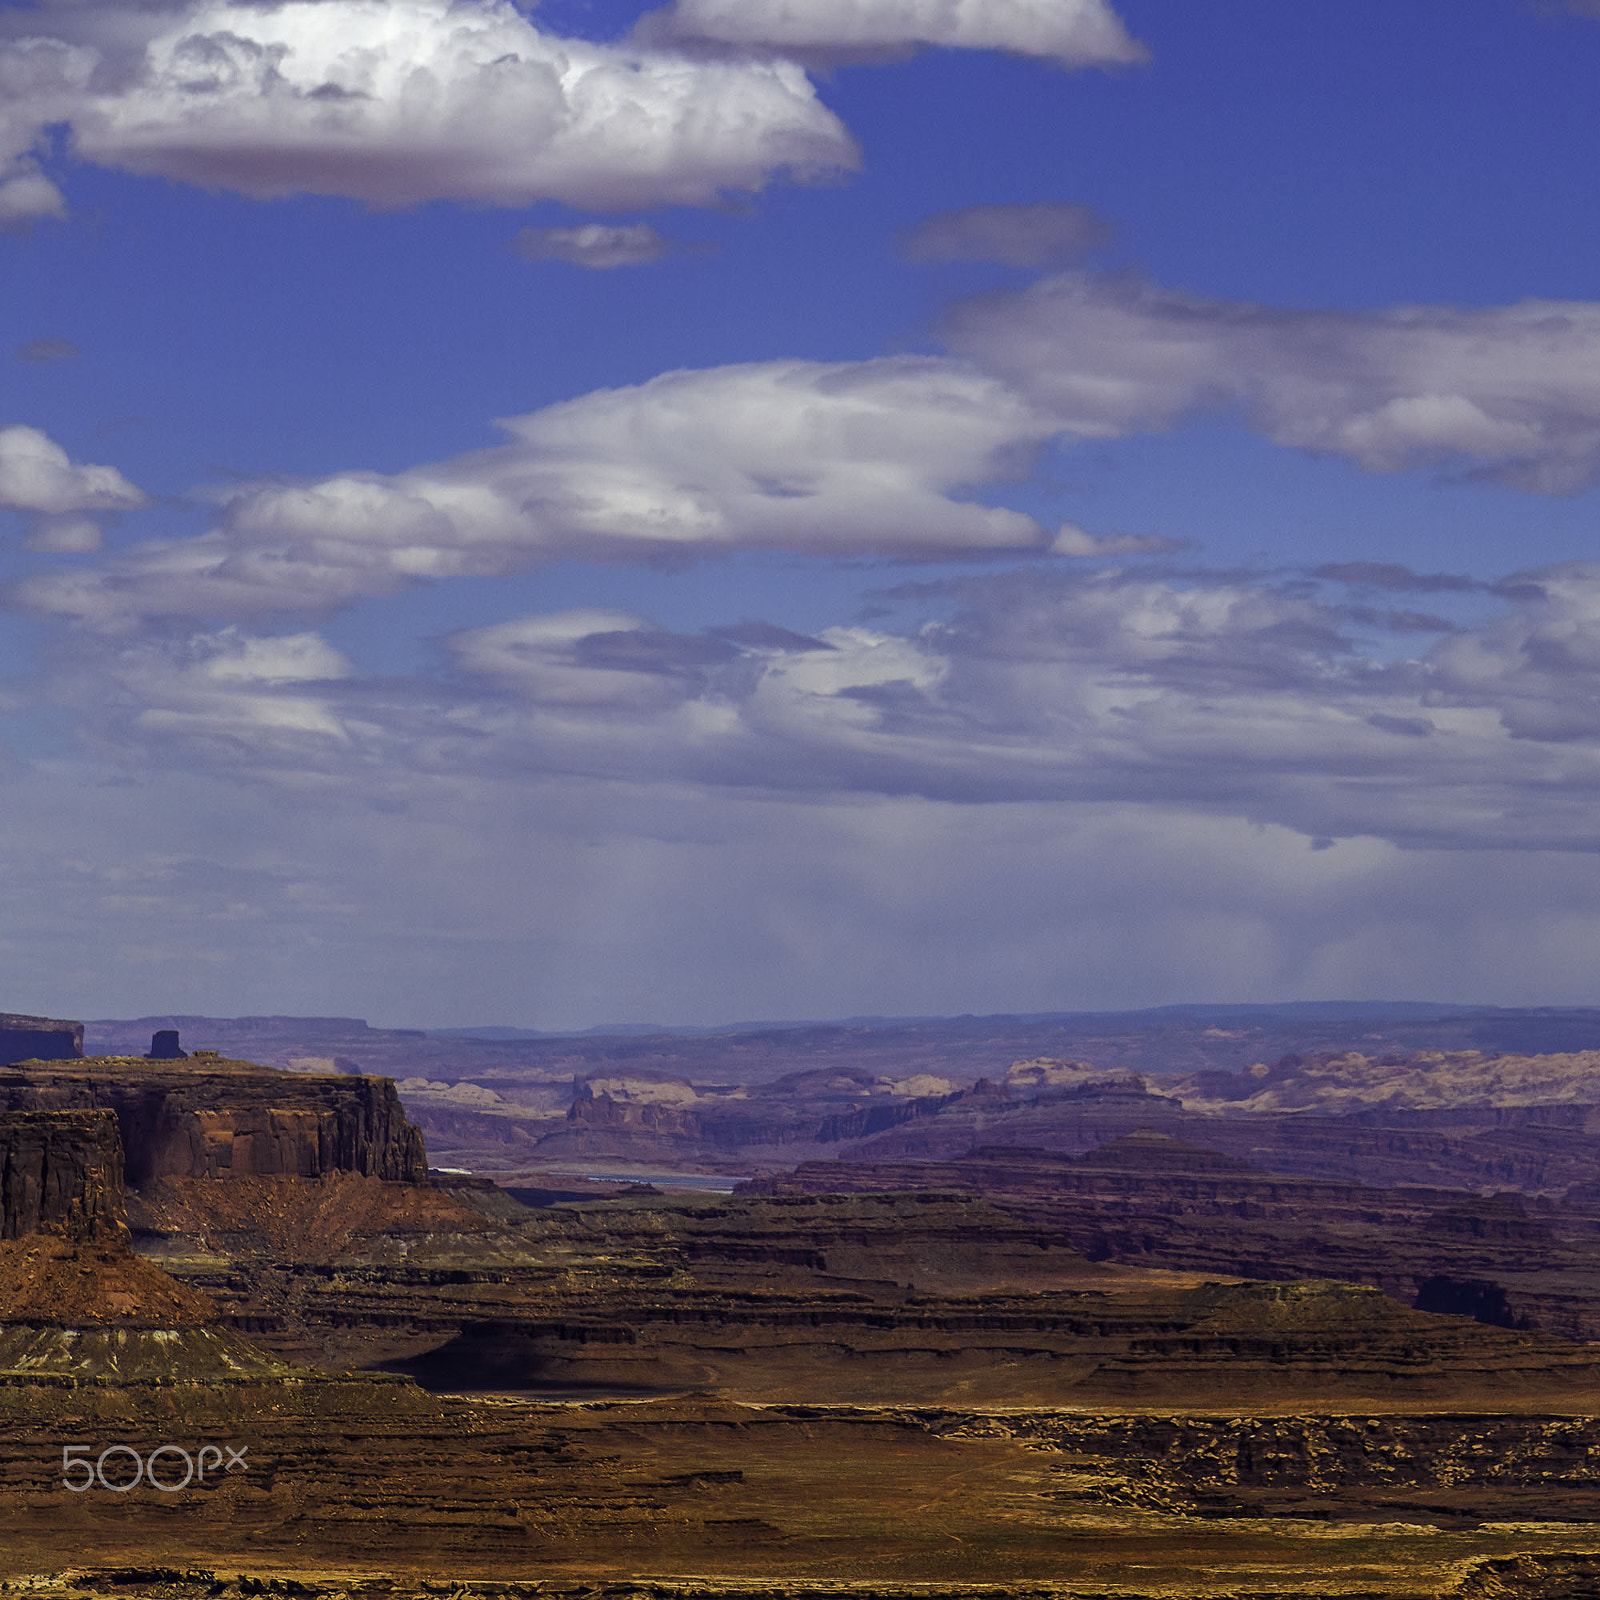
[128,1186,1600,1405]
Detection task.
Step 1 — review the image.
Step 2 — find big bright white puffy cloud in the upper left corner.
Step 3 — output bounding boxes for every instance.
[0,0,856,212]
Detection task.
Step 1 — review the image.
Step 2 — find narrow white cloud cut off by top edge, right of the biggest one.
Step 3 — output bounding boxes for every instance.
[640,0,1146,67]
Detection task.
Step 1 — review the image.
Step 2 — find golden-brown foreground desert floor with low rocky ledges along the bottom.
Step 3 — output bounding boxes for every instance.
[0,1384,1600,1600]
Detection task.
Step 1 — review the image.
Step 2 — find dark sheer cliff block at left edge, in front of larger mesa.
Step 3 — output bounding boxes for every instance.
[0,1110,128,1243]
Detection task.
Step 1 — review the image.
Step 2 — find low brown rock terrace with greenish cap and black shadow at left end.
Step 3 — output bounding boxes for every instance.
[371,1280,1600,1410]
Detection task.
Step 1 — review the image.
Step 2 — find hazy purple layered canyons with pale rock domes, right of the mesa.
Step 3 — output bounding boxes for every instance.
[467,1056,1600,1194]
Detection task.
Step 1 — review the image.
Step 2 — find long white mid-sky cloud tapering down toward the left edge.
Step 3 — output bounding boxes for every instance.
[13,357,1053,627]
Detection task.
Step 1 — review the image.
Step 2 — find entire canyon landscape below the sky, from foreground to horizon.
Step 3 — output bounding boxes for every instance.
[0,1016,1600,1600]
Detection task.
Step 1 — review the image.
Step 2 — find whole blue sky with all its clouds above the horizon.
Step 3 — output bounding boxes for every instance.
[0,0,1600,1027]
